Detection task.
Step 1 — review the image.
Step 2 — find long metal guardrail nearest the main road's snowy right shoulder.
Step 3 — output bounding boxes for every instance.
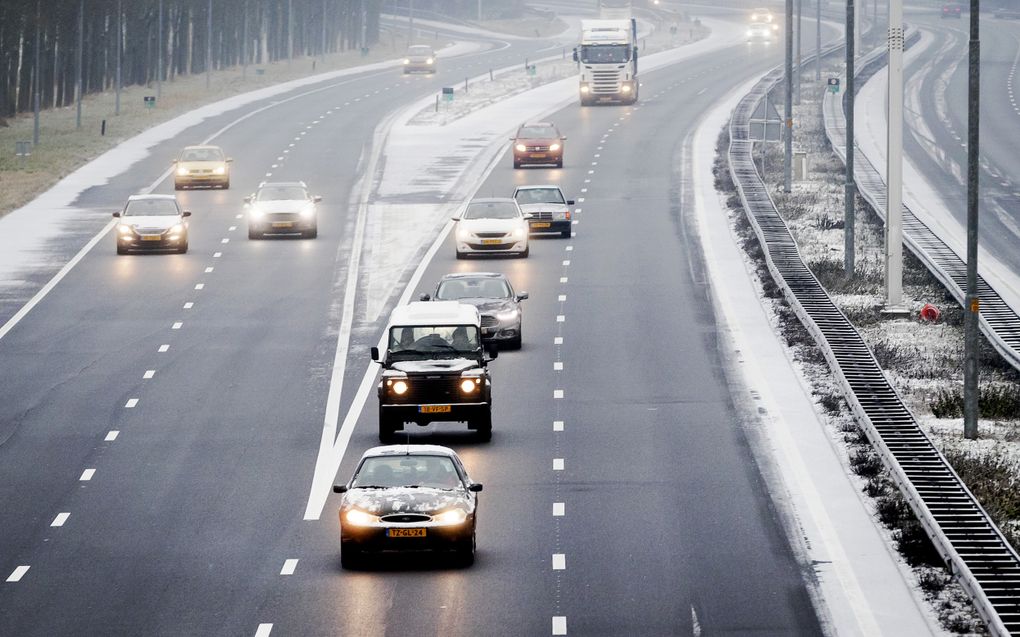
[728,63,1020,635]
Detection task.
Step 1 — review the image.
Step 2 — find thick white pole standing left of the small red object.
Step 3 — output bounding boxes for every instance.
[884,0,905,315]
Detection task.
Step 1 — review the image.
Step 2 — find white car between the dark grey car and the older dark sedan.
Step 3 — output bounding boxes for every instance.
[454,197,530,259]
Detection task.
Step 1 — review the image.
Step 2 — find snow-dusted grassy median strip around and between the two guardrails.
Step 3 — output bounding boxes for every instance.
[719,60,1020,633]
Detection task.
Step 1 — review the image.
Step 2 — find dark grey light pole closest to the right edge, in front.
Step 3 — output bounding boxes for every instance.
[963,0,981,440]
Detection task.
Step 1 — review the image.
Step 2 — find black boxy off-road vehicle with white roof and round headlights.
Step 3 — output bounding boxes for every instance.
[371,301,497,442]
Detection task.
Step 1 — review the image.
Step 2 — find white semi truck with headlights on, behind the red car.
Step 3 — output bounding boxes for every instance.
[573,17,639,106]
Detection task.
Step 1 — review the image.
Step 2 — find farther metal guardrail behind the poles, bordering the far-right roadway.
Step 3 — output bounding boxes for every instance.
[822,38,1020,369]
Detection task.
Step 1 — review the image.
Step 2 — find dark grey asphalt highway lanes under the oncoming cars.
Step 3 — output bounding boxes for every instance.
[0,6,836,635]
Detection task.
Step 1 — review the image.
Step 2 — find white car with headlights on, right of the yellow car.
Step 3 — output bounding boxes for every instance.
[245,181,322,238]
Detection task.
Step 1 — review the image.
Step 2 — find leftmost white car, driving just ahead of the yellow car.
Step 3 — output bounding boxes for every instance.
[113,195,191,255]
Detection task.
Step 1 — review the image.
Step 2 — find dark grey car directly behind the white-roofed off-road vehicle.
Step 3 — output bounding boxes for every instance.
[419,272,527,350]
